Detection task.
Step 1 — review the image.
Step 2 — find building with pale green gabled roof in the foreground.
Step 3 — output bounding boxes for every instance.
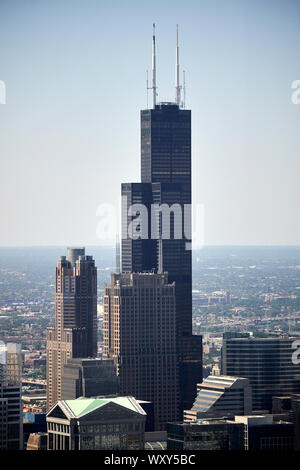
[47,397,146,450]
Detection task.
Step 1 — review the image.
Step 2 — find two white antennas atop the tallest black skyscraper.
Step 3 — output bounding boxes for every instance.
[147,23,185,109]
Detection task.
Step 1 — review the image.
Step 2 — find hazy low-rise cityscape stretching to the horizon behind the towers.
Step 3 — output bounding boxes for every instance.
[0,247,300,449]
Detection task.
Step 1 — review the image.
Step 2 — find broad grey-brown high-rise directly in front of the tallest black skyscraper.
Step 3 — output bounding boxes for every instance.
[103,273,179,430]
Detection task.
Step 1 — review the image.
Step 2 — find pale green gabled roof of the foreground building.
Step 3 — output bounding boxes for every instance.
[64,397,141,418]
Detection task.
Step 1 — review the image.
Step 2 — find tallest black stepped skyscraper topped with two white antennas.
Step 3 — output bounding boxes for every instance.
[122,25,202,414]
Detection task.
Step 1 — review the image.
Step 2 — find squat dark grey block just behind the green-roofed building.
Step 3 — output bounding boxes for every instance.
[61,359,119,400]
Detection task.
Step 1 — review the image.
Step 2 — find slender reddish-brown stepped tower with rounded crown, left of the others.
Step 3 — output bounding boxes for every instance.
[47,248,97,409]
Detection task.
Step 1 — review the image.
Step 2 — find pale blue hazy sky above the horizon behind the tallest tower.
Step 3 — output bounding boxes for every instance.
[0,0,300,245]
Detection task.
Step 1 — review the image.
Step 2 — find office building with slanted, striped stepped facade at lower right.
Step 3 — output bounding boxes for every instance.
[184,375,252,422]
